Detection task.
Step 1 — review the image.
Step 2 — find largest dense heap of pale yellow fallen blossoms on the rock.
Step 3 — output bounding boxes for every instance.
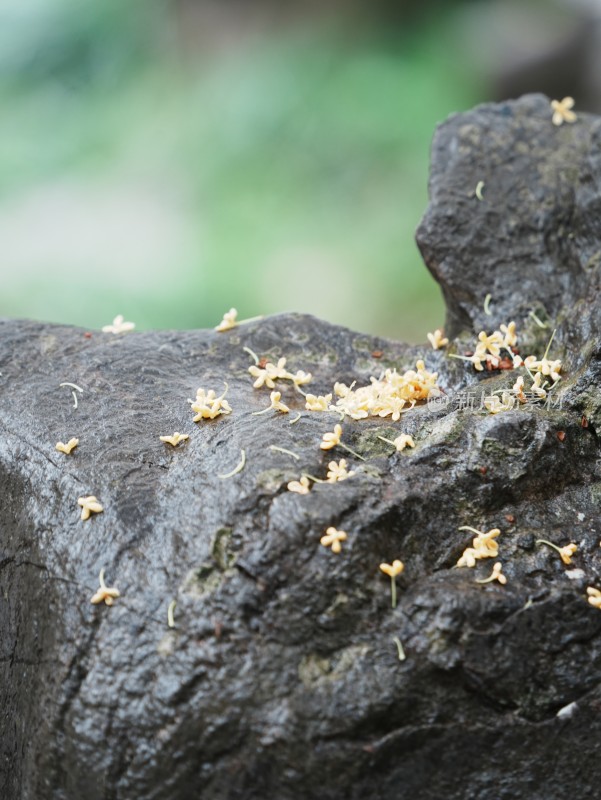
[332,361,439,422]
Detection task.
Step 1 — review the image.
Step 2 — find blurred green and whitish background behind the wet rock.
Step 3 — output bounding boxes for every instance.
[0,0,596,341]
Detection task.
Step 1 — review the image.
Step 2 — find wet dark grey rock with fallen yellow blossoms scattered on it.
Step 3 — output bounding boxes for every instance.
[0,96,601,800]
